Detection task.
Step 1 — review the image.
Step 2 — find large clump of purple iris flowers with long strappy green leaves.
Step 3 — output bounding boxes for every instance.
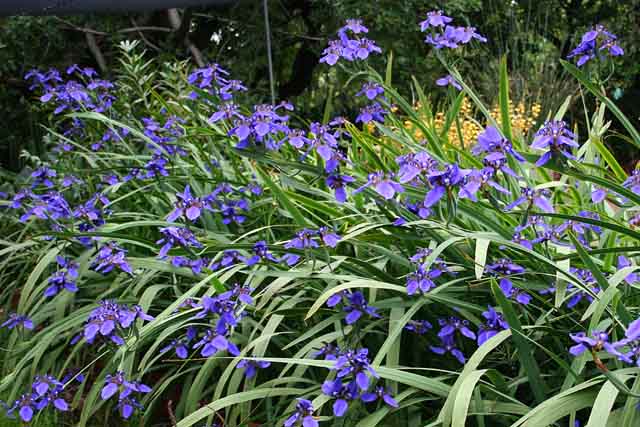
[0,11,640,427]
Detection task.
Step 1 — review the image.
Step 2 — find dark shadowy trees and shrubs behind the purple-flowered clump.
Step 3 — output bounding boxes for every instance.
[0,0,640,171]
